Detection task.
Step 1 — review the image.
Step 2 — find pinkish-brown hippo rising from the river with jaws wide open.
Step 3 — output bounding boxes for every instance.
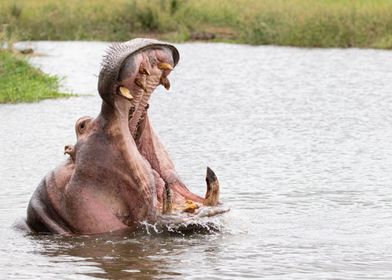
[26,38,228,235]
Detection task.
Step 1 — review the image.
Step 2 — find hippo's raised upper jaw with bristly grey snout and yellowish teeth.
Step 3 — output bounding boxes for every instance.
[98,38,180,137]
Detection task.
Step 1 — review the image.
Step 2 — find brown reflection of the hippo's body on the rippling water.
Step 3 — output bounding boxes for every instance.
[31,235,191,279]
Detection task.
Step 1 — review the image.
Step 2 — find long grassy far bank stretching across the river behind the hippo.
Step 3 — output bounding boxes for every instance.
[0,0,392,48]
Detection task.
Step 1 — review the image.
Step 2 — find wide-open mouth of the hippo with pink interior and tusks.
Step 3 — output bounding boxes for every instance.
[105,40,227,223]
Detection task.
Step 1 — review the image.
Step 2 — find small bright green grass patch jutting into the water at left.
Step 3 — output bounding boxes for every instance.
[0,50,70,103]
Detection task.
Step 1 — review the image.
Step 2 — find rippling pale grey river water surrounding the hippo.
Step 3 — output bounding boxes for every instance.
[0,42,392,279]
